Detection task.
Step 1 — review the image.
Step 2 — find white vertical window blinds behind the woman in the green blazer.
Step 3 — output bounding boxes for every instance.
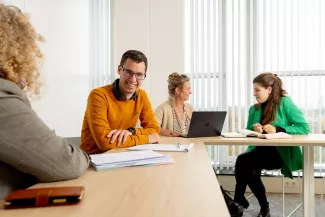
[185,0,325,171]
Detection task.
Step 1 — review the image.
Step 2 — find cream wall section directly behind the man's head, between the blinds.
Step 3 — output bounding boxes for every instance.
[114,0,185,108]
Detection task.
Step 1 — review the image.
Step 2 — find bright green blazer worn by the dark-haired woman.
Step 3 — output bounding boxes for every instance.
[246,97,310,178]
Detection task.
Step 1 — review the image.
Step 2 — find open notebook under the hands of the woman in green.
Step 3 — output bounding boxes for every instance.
[221,129,292,139]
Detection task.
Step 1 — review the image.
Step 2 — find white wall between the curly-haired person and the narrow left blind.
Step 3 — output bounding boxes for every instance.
[2,0,89,136]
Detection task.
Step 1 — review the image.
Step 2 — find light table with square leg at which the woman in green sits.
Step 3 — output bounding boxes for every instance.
[175,134,325,217]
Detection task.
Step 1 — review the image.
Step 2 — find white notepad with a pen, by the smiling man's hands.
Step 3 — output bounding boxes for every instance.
[128,143,194,152]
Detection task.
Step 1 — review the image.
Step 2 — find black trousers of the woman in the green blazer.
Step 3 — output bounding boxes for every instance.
[234,146,282,208]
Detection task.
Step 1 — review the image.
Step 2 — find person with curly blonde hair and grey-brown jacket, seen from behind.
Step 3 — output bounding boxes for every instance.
[0,4,89,200]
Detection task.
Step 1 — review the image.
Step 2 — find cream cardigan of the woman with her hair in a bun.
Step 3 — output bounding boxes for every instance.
[155,100,193,134]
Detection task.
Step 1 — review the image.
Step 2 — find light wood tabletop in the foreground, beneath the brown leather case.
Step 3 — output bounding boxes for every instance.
[0,137,230,217]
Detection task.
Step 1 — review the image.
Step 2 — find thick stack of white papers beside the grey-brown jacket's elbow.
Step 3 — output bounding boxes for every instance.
[90,150,173,171]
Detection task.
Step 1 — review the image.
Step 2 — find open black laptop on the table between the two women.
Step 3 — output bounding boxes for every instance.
[181,111,227,138]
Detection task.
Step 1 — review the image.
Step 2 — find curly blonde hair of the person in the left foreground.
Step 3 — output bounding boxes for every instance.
[0,4,44,95]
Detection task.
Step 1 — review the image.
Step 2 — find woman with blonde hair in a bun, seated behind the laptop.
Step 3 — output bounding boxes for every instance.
[155,72,193,136]
